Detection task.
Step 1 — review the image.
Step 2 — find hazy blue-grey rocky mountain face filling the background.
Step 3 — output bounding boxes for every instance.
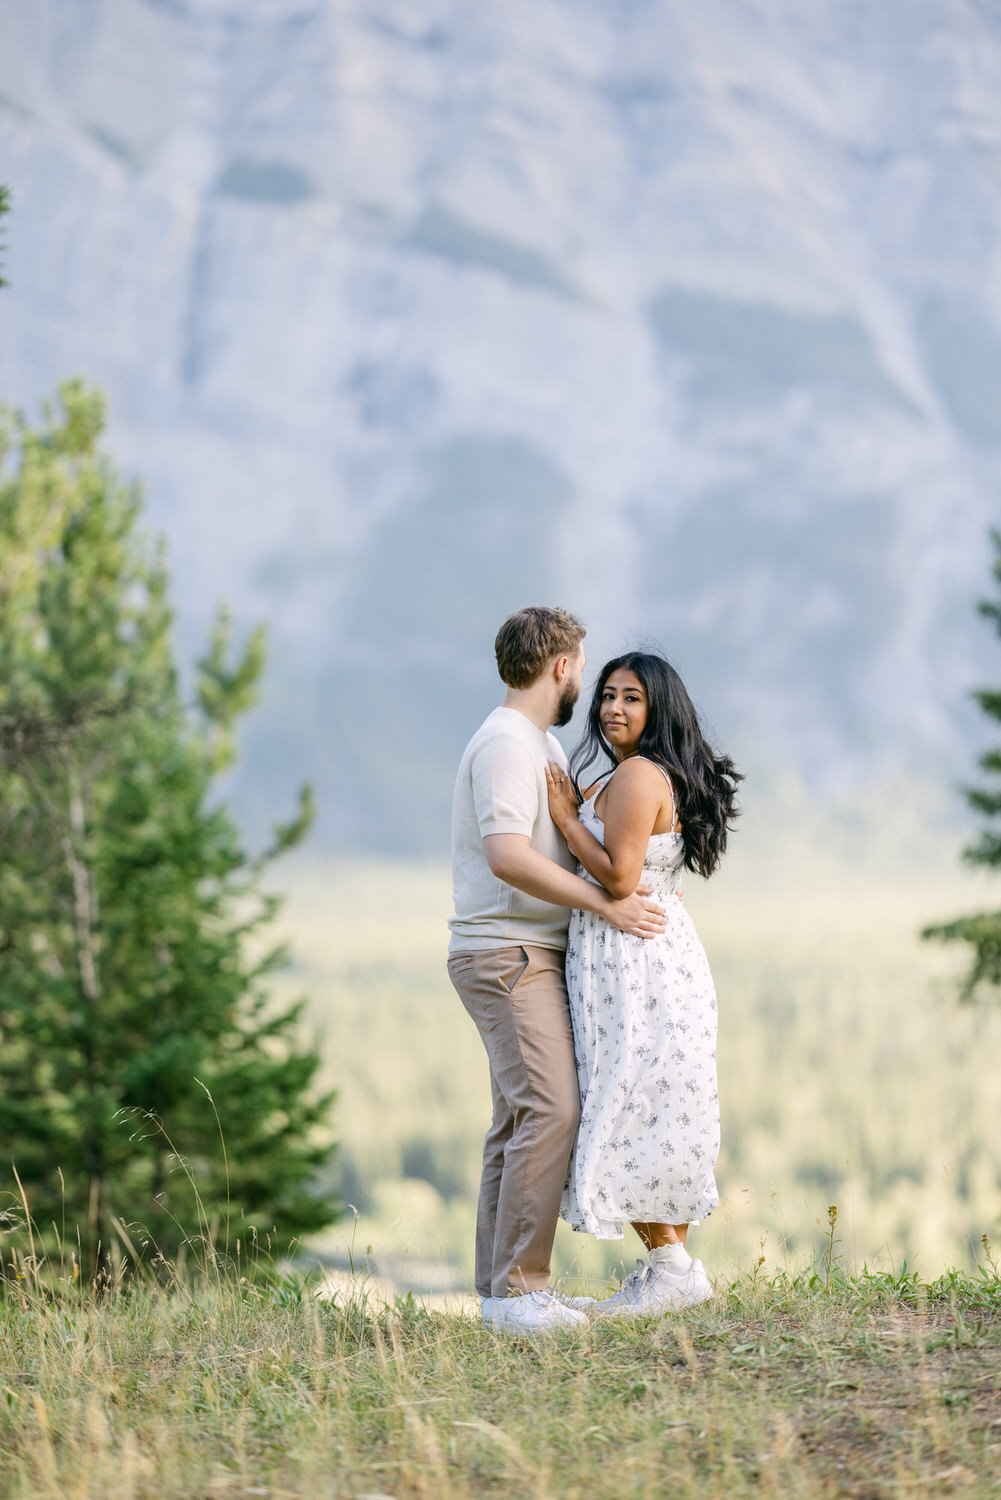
[0,0,1001,852]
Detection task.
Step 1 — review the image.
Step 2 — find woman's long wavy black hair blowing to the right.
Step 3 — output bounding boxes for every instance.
[570,651,743,876]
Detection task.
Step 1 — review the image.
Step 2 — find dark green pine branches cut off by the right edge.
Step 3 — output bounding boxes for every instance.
[921,531,1001,1001]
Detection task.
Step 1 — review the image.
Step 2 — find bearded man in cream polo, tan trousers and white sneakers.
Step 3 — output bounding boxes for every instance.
[449,608,665,1334]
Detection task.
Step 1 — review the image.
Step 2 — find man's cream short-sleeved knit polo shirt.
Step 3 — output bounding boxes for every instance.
[449,708,576,954]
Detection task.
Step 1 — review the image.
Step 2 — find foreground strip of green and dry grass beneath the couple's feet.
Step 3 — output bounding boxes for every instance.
[0,1268,1001,1500]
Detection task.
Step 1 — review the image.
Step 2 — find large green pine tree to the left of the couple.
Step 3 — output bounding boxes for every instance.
[0,383,336,1272]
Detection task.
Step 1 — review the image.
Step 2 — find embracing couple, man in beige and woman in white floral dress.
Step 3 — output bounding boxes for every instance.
[449,608,740,1334]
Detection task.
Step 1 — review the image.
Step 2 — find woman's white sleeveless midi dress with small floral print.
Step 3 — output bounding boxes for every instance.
[560,768,719,1239]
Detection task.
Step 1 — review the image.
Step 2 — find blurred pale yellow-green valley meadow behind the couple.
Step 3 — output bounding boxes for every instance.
[270,795,1001,1290]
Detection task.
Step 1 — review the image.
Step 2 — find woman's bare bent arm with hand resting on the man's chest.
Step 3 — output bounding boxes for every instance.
[546,759,666,899]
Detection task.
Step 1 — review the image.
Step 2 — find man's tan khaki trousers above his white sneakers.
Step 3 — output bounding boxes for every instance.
[449,947,581,1298]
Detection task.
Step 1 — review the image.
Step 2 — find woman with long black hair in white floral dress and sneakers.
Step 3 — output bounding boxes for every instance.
[548,653,741,1316]
